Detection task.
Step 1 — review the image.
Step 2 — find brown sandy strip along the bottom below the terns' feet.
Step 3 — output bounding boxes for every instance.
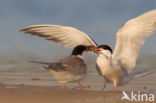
[0,84,156,103]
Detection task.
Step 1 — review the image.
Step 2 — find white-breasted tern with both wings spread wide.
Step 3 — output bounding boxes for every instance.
[21,10,156,90]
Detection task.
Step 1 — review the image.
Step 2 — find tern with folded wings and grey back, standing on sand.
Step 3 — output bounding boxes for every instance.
[31,45,94,90]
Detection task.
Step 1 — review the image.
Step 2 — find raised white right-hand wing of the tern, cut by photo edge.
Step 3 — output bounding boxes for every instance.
[112,9,156,72]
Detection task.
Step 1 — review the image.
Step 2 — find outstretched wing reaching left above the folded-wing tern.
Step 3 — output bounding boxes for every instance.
[21,25,96,48]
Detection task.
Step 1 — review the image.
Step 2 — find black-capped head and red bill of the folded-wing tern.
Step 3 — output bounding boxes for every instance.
[72,45,96,55]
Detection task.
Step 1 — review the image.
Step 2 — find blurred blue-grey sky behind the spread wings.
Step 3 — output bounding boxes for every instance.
[0,0,156,55]
